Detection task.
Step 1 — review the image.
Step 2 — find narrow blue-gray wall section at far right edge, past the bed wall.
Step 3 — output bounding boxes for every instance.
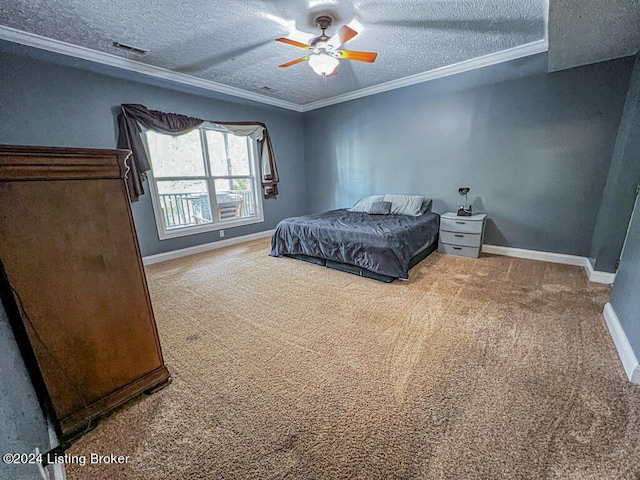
[590,54,640,272]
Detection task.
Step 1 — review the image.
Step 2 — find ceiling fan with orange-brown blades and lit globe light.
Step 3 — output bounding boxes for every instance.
[276,15,378,78]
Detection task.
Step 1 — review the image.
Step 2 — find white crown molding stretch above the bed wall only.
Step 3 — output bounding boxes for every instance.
[302,39,549,112]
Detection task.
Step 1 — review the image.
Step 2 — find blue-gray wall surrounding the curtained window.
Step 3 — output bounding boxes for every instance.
[0,42,305,255]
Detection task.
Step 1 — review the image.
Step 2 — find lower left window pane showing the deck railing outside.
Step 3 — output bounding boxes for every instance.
[157,180,211,229]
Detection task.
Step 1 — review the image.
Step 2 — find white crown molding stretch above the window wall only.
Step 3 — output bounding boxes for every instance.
[0,25,302,112]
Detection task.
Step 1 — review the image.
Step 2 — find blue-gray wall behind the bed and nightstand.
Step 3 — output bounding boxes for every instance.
[304,54,633,256]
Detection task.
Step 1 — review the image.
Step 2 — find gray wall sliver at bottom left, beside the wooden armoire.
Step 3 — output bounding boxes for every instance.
[0,303,50,480]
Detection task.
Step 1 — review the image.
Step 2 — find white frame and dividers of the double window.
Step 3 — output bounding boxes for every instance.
[142,123,264,240]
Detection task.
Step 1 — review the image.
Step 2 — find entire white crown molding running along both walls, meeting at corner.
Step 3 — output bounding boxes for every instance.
[0,25,549,112]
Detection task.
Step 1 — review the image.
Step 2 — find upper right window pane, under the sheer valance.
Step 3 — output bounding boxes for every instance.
[207,130,251,176]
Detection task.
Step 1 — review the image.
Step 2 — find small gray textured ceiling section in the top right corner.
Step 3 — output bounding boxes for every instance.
[549,0,640,72]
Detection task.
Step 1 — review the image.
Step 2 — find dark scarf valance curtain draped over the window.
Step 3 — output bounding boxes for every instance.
[118,104,280,202]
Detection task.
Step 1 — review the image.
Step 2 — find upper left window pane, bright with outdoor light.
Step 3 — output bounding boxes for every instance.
[146,130,204,177]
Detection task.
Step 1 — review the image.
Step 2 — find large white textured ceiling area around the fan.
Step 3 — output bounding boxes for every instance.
[0,0,547,106]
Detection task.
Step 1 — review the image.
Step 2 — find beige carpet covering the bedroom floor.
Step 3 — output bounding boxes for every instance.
[67,239,640,480]
